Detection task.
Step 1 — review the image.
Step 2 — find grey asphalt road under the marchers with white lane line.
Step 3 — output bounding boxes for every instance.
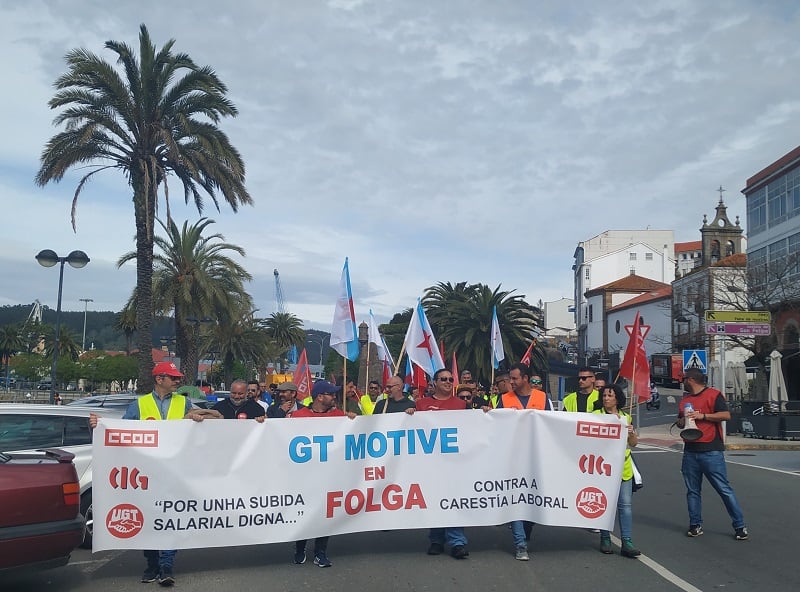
[0,390,800,592]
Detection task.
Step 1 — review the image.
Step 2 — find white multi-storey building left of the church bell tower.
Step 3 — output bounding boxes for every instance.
[572,230,675,354]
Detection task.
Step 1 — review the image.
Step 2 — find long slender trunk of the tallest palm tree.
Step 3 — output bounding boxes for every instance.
[132,178,156,393]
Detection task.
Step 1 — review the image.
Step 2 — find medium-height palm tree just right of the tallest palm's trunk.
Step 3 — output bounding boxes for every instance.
[117,218,252,384]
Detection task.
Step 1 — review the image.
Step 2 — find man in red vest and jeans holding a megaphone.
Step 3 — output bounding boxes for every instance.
[678,368,749,541]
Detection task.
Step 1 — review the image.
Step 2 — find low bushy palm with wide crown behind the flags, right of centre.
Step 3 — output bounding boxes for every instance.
[422,283,548,381]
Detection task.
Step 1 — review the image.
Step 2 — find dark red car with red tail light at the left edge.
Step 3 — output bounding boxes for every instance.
[0,449,84,573]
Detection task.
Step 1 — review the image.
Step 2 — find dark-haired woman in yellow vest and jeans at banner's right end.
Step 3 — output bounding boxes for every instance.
[594,384,642,557]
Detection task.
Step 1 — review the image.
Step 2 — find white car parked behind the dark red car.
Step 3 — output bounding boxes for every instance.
[0,403,125,549]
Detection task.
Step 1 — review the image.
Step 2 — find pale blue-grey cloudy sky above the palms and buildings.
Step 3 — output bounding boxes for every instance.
[0,0,800,329]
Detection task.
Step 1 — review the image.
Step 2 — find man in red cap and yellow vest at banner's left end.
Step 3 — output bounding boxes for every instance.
[89,362,222,586]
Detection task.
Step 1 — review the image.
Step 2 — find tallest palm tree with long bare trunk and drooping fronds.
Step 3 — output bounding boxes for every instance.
[36,25,252,392]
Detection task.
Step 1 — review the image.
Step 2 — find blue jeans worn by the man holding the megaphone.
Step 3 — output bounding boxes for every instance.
[681,450,744,528]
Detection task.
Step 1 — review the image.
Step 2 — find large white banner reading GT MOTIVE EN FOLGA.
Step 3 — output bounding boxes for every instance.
[93,409,627,551]
